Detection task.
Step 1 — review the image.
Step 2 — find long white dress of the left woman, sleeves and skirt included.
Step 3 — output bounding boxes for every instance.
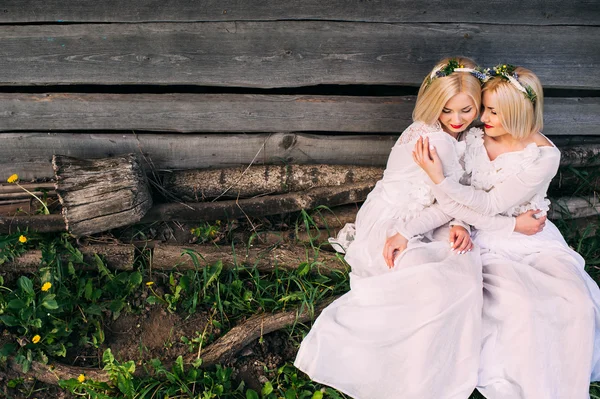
[294,123,514,399]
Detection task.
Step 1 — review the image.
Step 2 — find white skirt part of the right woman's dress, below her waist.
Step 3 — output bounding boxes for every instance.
[475,222,600,399]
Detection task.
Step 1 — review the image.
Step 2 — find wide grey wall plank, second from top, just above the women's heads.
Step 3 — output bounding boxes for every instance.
[0,21,600,88]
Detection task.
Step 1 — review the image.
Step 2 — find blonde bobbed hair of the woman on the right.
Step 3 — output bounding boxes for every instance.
[483,67,544,139]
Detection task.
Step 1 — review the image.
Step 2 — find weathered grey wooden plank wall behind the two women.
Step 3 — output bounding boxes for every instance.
[0,0,600,219]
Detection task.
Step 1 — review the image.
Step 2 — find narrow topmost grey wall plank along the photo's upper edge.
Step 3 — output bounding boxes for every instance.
[0,0,600,25]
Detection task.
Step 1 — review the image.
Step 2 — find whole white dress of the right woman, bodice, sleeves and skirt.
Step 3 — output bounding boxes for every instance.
[433,133,600,399]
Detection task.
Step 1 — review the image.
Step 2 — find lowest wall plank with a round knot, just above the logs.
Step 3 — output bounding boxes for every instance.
[0,133,600,181]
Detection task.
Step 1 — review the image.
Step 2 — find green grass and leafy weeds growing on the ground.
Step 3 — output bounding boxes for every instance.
[0,209,600,399]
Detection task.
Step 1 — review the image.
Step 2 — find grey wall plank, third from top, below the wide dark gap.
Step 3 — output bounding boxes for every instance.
[0,93,600,135]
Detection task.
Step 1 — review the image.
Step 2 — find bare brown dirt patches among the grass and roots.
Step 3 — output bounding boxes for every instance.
[0,284,296,399]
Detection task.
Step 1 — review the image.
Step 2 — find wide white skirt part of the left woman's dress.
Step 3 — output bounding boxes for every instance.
[294,229,483,399]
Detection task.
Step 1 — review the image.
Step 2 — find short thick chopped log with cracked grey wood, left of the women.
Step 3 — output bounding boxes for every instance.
[52,154,152,237]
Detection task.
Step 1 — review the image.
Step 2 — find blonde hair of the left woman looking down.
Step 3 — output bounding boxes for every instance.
[413,57,481,125]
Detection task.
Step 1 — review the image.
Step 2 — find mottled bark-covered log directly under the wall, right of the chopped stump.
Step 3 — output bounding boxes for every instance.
[163,164,383,201]
